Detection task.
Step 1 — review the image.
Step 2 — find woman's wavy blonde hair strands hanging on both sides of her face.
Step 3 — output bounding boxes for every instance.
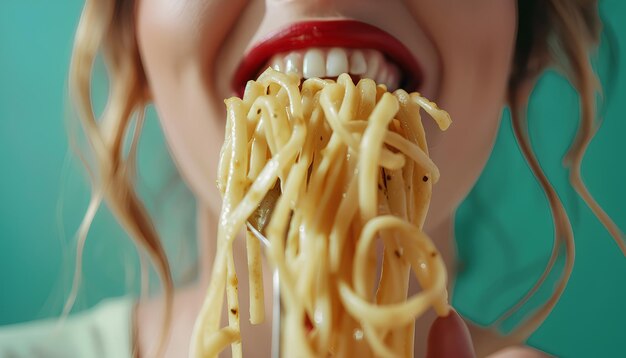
[66,0,626,355]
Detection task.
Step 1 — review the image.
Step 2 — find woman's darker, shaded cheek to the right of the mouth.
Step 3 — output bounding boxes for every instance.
[404,0,517,225]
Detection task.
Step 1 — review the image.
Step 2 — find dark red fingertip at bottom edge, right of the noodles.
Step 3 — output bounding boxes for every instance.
[426,310,476,358]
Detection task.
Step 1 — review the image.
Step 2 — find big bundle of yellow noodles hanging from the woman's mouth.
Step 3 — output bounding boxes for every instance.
[191,68,450,357]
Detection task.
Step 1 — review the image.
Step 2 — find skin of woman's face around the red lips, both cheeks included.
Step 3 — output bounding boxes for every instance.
[137,0,517,229]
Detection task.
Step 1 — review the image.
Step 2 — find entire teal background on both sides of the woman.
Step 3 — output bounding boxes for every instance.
[0,0,626,357]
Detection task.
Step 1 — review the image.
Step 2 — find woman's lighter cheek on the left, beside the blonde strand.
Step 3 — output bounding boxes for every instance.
[136,0,245,206]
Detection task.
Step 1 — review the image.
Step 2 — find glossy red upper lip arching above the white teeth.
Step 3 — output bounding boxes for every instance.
[232,20,423,95]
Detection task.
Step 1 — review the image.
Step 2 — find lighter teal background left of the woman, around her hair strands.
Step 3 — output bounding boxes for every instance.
[0,0,196,325]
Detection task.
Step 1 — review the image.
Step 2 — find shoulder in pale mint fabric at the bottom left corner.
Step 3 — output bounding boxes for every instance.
[0,298,133,358]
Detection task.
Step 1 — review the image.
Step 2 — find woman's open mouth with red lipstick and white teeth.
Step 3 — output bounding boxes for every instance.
[232,20,422,96]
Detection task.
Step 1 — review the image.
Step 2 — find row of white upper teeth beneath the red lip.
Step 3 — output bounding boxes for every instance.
[269,47,400,91]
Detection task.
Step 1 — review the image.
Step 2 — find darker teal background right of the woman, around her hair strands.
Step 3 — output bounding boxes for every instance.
[454,0,626,357]
